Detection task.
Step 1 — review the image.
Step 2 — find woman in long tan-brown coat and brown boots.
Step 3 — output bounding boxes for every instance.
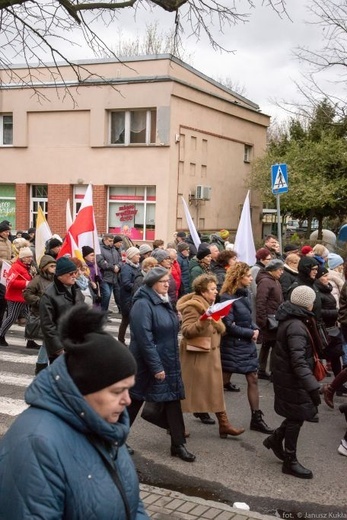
[177,274,245,438]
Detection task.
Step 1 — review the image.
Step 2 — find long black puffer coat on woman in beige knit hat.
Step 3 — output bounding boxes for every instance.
[272,301,320,421]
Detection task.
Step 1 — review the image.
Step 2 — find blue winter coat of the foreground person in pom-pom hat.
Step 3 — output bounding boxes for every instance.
[0,356,148,520]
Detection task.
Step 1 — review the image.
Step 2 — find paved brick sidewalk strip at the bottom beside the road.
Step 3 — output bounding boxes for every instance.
[140,484,274,520]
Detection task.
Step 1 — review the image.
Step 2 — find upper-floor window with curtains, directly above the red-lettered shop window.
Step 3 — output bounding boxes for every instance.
[110,109,157,146]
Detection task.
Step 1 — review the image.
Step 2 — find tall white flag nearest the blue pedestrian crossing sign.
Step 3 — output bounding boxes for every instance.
[234,190,255,265]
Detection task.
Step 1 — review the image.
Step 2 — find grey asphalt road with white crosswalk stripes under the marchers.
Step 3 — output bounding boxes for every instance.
[0,317,347,519]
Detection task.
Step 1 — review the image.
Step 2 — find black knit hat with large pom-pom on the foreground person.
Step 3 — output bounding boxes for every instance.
[59,304,137,395]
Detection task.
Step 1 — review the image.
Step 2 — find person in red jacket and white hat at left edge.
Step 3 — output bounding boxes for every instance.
[0,247,36,347]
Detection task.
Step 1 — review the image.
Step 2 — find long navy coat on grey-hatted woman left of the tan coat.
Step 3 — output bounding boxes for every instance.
[130,285,184,402]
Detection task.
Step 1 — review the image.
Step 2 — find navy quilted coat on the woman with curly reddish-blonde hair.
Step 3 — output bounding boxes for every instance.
[220,288,258,374]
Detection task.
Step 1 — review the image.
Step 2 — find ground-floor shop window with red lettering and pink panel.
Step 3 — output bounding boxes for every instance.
[108,186,156,240]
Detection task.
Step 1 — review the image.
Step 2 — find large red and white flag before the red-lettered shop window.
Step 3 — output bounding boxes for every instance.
[59,184,100,257]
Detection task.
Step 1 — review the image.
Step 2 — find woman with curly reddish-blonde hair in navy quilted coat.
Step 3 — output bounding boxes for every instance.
[220,262,273,433]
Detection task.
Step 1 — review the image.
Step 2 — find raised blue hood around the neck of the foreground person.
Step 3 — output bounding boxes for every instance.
[25,355,129,445]
